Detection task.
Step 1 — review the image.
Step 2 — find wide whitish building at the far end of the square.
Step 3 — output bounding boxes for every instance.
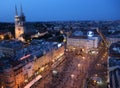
[67,32,99,52]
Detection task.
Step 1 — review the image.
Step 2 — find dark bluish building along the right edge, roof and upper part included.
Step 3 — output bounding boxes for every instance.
[108,42,120,88]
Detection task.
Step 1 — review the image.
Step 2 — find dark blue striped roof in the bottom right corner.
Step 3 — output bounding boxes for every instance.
[109,57,120,88]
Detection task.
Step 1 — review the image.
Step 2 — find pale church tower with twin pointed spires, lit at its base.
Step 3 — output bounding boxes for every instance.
[15,5,25,40]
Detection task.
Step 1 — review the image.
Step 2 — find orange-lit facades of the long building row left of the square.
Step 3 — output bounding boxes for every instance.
[0,41,65,88]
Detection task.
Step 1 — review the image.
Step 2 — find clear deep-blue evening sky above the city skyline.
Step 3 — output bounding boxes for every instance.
[0,0,120,22]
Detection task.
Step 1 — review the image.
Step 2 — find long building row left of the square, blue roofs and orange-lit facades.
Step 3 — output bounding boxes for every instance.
[0,40,65,88]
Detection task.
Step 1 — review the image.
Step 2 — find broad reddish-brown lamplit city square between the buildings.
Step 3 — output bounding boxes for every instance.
[31,49,107,88]
